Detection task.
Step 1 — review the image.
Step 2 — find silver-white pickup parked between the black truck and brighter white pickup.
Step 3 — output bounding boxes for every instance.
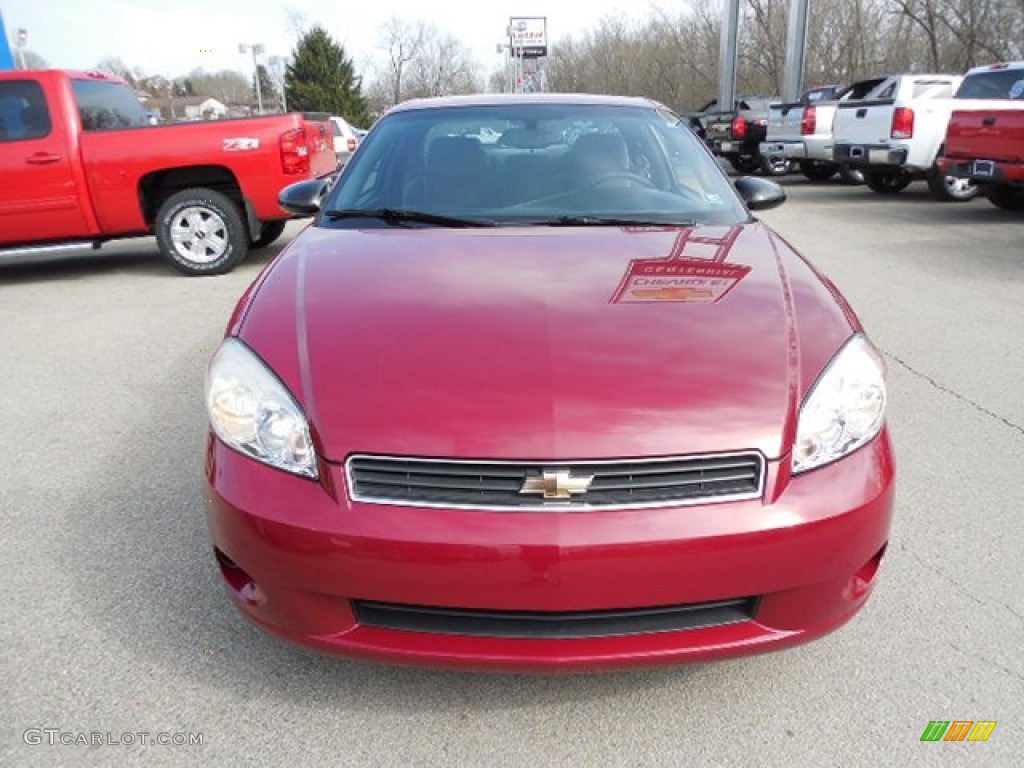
[761,78,885,184]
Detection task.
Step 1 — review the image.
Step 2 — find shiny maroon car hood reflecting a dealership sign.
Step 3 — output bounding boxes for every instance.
[233,223,857,461]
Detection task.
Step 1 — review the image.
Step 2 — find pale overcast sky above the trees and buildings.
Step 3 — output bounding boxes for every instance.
[0,0,659,79]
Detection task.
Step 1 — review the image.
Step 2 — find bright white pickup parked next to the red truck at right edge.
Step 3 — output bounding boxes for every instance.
[833,75,978,201]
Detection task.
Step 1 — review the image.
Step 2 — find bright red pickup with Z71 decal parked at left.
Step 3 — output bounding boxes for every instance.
[0,70,337,274]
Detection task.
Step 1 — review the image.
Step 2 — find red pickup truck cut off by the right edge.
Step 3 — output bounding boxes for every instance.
[938,61,1024,211]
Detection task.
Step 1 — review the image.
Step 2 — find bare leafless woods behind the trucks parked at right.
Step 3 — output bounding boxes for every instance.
[548,0,1024,110]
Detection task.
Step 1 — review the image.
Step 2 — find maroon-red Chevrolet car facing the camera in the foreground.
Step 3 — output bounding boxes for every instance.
[206,94,893,671]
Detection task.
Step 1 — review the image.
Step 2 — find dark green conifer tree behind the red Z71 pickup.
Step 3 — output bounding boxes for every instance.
[285,25,370,126]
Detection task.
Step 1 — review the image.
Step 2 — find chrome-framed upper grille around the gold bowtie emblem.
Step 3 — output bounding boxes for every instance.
[346,452,764,510]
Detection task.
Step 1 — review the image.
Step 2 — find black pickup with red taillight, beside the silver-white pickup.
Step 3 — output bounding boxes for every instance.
[704,96,793,176]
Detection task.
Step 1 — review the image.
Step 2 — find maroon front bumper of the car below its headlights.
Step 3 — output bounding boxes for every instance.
[207,432,893,671]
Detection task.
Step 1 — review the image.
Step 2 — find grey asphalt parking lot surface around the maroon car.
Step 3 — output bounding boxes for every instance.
[0,182,1024,766]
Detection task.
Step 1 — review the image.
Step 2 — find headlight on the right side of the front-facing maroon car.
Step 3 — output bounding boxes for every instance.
[793,334,886,474]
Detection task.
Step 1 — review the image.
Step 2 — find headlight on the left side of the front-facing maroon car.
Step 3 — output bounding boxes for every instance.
[206,339,316,478]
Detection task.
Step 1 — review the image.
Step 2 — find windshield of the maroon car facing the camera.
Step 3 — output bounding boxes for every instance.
[318,102,749,227]
